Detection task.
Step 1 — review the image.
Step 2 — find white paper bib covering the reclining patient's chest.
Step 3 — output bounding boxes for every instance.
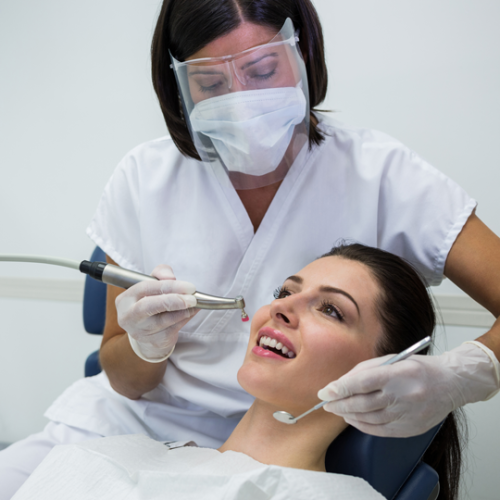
[14,435,384,500]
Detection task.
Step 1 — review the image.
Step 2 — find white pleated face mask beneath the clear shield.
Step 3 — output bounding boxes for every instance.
[190,86,307,175]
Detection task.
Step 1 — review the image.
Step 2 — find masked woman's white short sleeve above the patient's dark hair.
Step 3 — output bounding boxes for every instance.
[370,129,477,286]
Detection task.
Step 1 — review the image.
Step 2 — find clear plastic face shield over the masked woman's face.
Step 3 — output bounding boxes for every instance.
[171,19,309,189]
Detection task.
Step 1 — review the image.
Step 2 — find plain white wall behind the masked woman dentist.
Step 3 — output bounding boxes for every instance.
[0,0,500,499]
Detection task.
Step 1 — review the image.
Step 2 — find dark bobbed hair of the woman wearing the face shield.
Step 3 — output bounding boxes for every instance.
[151,0,328,160]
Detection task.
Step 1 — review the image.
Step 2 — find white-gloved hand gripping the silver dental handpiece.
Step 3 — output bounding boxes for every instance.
[116,265,198,363]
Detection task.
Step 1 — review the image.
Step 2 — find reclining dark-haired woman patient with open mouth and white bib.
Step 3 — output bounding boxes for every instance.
[14,244,460,500]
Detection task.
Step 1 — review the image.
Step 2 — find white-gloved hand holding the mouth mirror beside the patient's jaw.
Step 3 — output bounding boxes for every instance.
[318,342,500,437]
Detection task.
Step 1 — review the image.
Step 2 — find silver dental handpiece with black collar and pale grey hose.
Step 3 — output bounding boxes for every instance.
[0,254,249,321]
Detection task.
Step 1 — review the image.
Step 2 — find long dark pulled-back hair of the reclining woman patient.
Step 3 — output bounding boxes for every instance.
[320,243,466,500]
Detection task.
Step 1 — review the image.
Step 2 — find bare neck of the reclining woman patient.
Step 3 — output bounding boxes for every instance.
[219,400,346,471]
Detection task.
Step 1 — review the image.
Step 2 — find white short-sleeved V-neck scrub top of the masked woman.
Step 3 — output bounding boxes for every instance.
[46,118,476,446]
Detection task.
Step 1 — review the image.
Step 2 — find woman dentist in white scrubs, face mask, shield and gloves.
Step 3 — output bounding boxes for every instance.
[0,0,500,498]
